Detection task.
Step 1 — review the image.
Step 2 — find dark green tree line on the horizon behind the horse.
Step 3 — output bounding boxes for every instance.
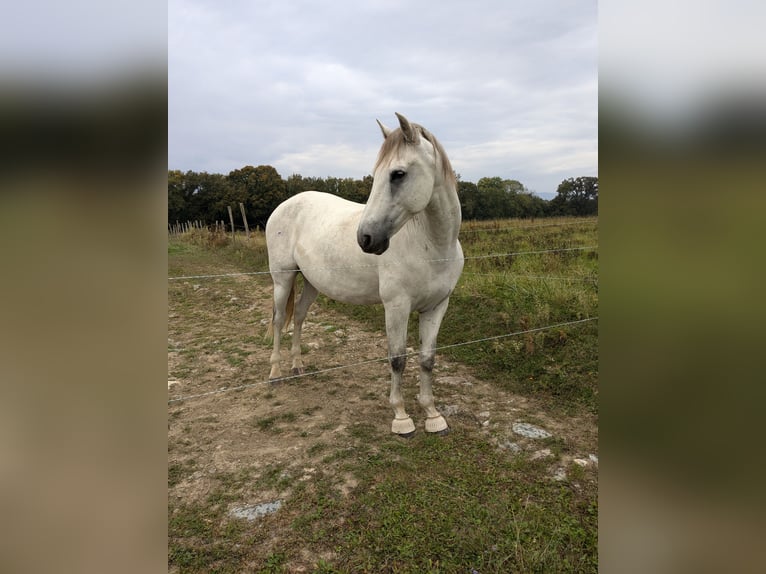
[168,165,598,228]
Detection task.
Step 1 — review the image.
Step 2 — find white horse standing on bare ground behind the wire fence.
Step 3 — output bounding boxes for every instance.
[266,114,463,436]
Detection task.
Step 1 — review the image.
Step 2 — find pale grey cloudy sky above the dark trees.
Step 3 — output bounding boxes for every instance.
[168,0,598,197]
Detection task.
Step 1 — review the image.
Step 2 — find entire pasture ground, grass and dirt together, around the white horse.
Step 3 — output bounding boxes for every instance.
[168,218,598,574]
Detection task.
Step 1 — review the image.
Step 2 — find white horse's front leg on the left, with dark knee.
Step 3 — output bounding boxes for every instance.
[385,304,415,438]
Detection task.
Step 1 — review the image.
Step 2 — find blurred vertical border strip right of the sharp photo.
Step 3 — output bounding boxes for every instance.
[599,1,766,573]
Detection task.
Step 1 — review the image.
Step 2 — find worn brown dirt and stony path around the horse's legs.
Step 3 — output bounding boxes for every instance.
[168,277,597,505]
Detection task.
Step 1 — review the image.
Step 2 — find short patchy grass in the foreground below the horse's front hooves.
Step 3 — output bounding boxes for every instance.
[169,430,597,574]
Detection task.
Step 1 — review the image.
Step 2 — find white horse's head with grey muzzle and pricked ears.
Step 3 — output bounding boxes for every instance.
[356,113,438,255]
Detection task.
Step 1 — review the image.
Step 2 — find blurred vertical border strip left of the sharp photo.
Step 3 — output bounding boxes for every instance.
[0,0,167,573]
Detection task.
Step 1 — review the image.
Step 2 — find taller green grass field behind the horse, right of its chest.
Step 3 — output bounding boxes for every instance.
[319,218,598,413]
